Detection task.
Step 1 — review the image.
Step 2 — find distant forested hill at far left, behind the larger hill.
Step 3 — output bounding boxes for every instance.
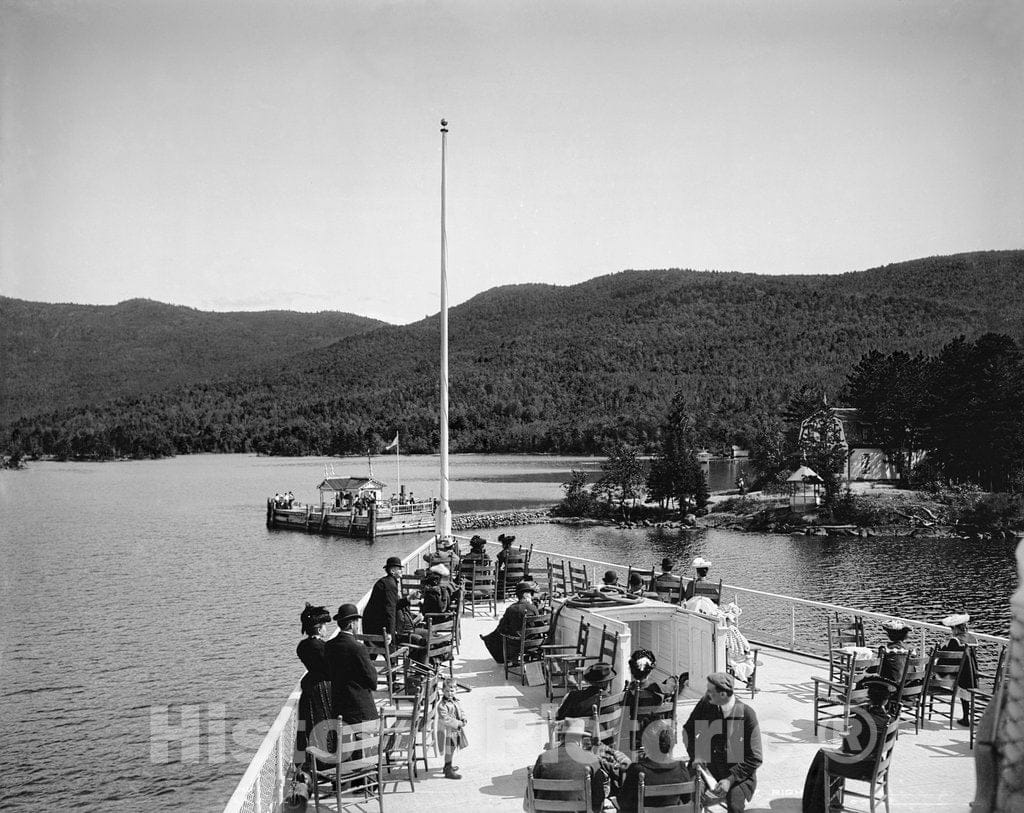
[0,297,384,420]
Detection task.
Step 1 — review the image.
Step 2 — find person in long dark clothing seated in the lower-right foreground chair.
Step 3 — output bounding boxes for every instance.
[804,678,896,813]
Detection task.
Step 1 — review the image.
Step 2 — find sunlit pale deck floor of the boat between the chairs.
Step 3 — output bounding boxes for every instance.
[310,607,974,813]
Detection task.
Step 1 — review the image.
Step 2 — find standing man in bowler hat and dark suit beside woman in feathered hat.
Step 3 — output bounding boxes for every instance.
[324,604,377,723]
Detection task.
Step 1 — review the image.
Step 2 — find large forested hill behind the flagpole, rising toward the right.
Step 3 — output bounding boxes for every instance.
[2,251,1024,455]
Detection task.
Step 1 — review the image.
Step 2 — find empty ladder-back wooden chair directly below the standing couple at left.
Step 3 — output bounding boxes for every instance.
[306,719,384,813]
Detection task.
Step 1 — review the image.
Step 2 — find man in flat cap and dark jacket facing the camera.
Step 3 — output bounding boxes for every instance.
[683,672,763,813]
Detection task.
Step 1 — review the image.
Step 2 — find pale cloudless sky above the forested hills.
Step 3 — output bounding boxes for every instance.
[0,0,1024,324]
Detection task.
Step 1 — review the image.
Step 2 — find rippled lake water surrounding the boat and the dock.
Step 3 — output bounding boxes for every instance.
[0,456,1015,811]
